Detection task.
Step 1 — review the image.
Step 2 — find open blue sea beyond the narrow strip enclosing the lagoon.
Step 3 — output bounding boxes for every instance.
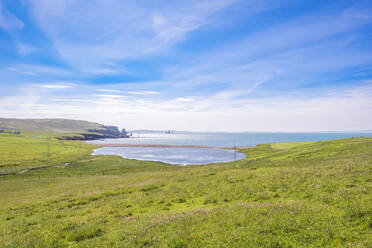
[87,130,372,147]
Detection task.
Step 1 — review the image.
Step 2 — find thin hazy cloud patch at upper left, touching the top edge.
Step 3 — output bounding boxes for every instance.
[26,0,241,73]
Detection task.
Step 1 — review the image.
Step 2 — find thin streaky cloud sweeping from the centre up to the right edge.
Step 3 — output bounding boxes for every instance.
[153,3,372,97]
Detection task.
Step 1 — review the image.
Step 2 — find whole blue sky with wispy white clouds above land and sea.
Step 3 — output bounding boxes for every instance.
[0,0,372,132]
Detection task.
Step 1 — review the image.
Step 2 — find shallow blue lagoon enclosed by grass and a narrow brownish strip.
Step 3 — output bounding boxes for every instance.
[93,147,246,165]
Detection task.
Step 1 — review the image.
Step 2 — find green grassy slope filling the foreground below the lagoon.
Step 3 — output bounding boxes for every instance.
[0,138,372,247]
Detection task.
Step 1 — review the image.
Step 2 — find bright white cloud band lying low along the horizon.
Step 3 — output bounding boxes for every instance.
[0,81,372,131]
